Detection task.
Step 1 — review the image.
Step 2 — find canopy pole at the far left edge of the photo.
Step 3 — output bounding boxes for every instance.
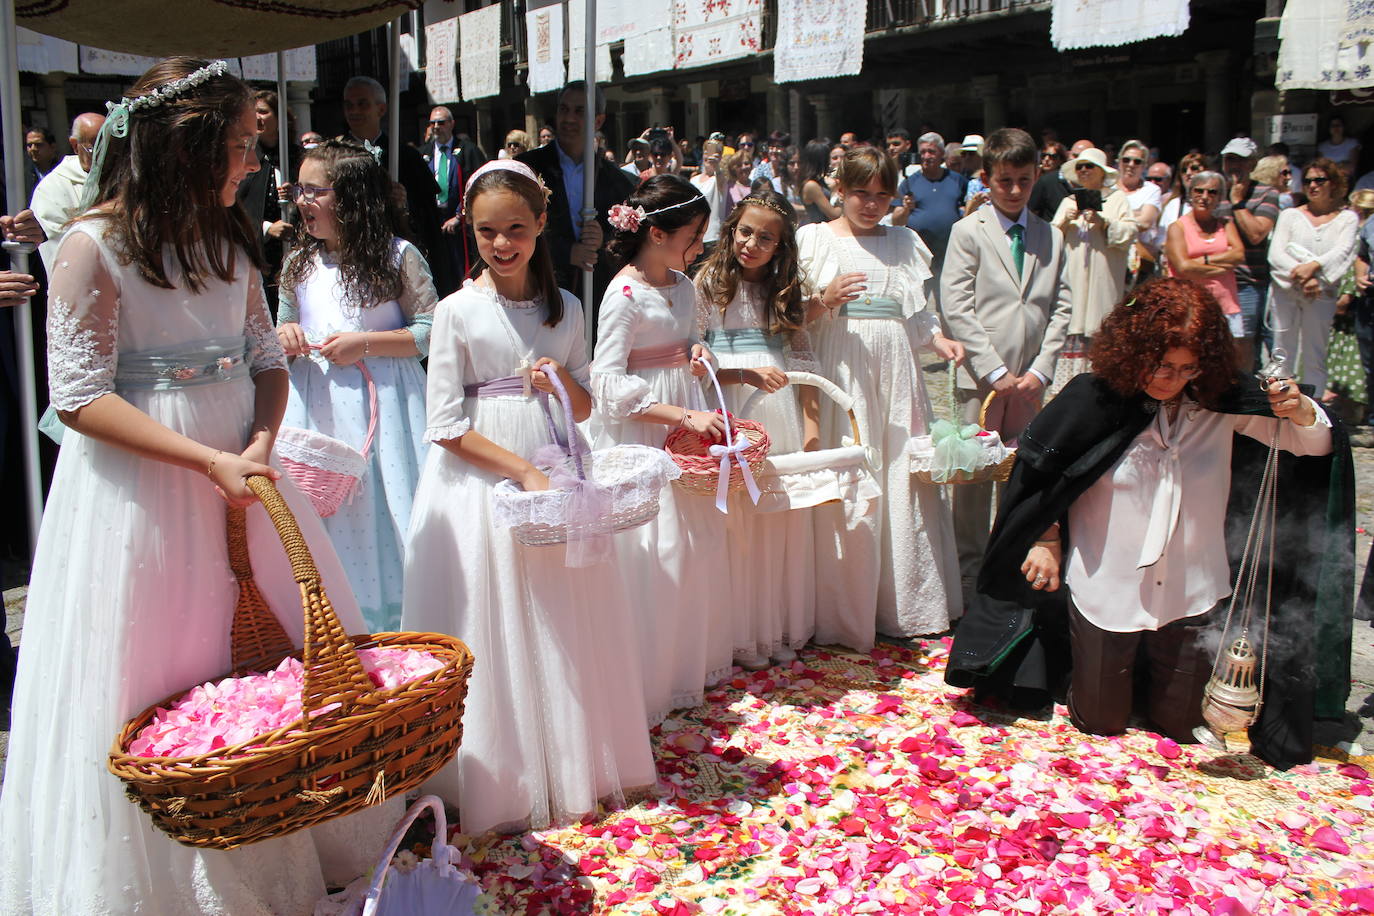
[0,0,43,559]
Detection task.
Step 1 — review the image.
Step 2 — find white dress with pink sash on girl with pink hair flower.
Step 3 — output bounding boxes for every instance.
[591,271,743,724]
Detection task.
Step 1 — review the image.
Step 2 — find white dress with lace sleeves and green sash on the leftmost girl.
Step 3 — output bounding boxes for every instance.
[0,221,401,916]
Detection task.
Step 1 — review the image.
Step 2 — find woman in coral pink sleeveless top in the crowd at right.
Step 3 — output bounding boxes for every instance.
[1164,172,1245,358]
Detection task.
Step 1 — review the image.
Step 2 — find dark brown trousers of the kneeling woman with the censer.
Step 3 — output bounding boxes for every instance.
[1069,602,1216,742]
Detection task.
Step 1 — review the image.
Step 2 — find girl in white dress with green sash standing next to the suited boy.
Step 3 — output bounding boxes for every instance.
[797,148,963,645]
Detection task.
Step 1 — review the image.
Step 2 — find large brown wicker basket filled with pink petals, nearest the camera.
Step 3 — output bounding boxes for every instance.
[109,477,473,849]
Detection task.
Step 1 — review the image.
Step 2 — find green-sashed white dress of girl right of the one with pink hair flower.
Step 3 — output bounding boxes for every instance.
[698,282,819,661]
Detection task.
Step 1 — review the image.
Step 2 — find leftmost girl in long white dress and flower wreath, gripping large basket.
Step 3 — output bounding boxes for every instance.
[0,58,400,916]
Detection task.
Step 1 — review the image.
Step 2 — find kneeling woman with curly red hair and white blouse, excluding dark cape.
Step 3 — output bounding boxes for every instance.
[1022,279,1331,740]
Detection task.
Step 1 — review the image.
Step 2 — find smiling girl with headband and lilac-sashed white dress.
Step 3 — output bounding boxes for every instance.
[401,159,655,834]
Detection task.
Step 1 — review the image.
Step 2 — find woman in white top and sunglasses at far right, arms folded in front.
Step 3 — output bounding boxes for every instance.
[1270,158,1360,396]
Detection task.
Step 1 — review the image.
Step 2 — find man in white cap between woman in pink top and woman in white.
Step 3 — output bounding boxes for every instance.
[1216,137,1279,357]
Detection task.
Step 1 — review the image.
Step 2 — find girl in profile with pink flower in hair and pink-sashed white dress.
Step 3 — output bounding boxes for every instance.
[591,174,743,724]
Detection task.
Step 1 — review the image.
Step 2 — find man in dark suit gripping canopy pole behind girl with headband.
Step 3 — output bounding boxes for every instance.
[518,80,633,321]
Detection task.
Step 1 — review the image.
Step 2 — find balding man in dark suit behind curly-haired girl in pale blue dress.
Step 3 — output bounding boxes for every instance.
[341,77,458,295]
